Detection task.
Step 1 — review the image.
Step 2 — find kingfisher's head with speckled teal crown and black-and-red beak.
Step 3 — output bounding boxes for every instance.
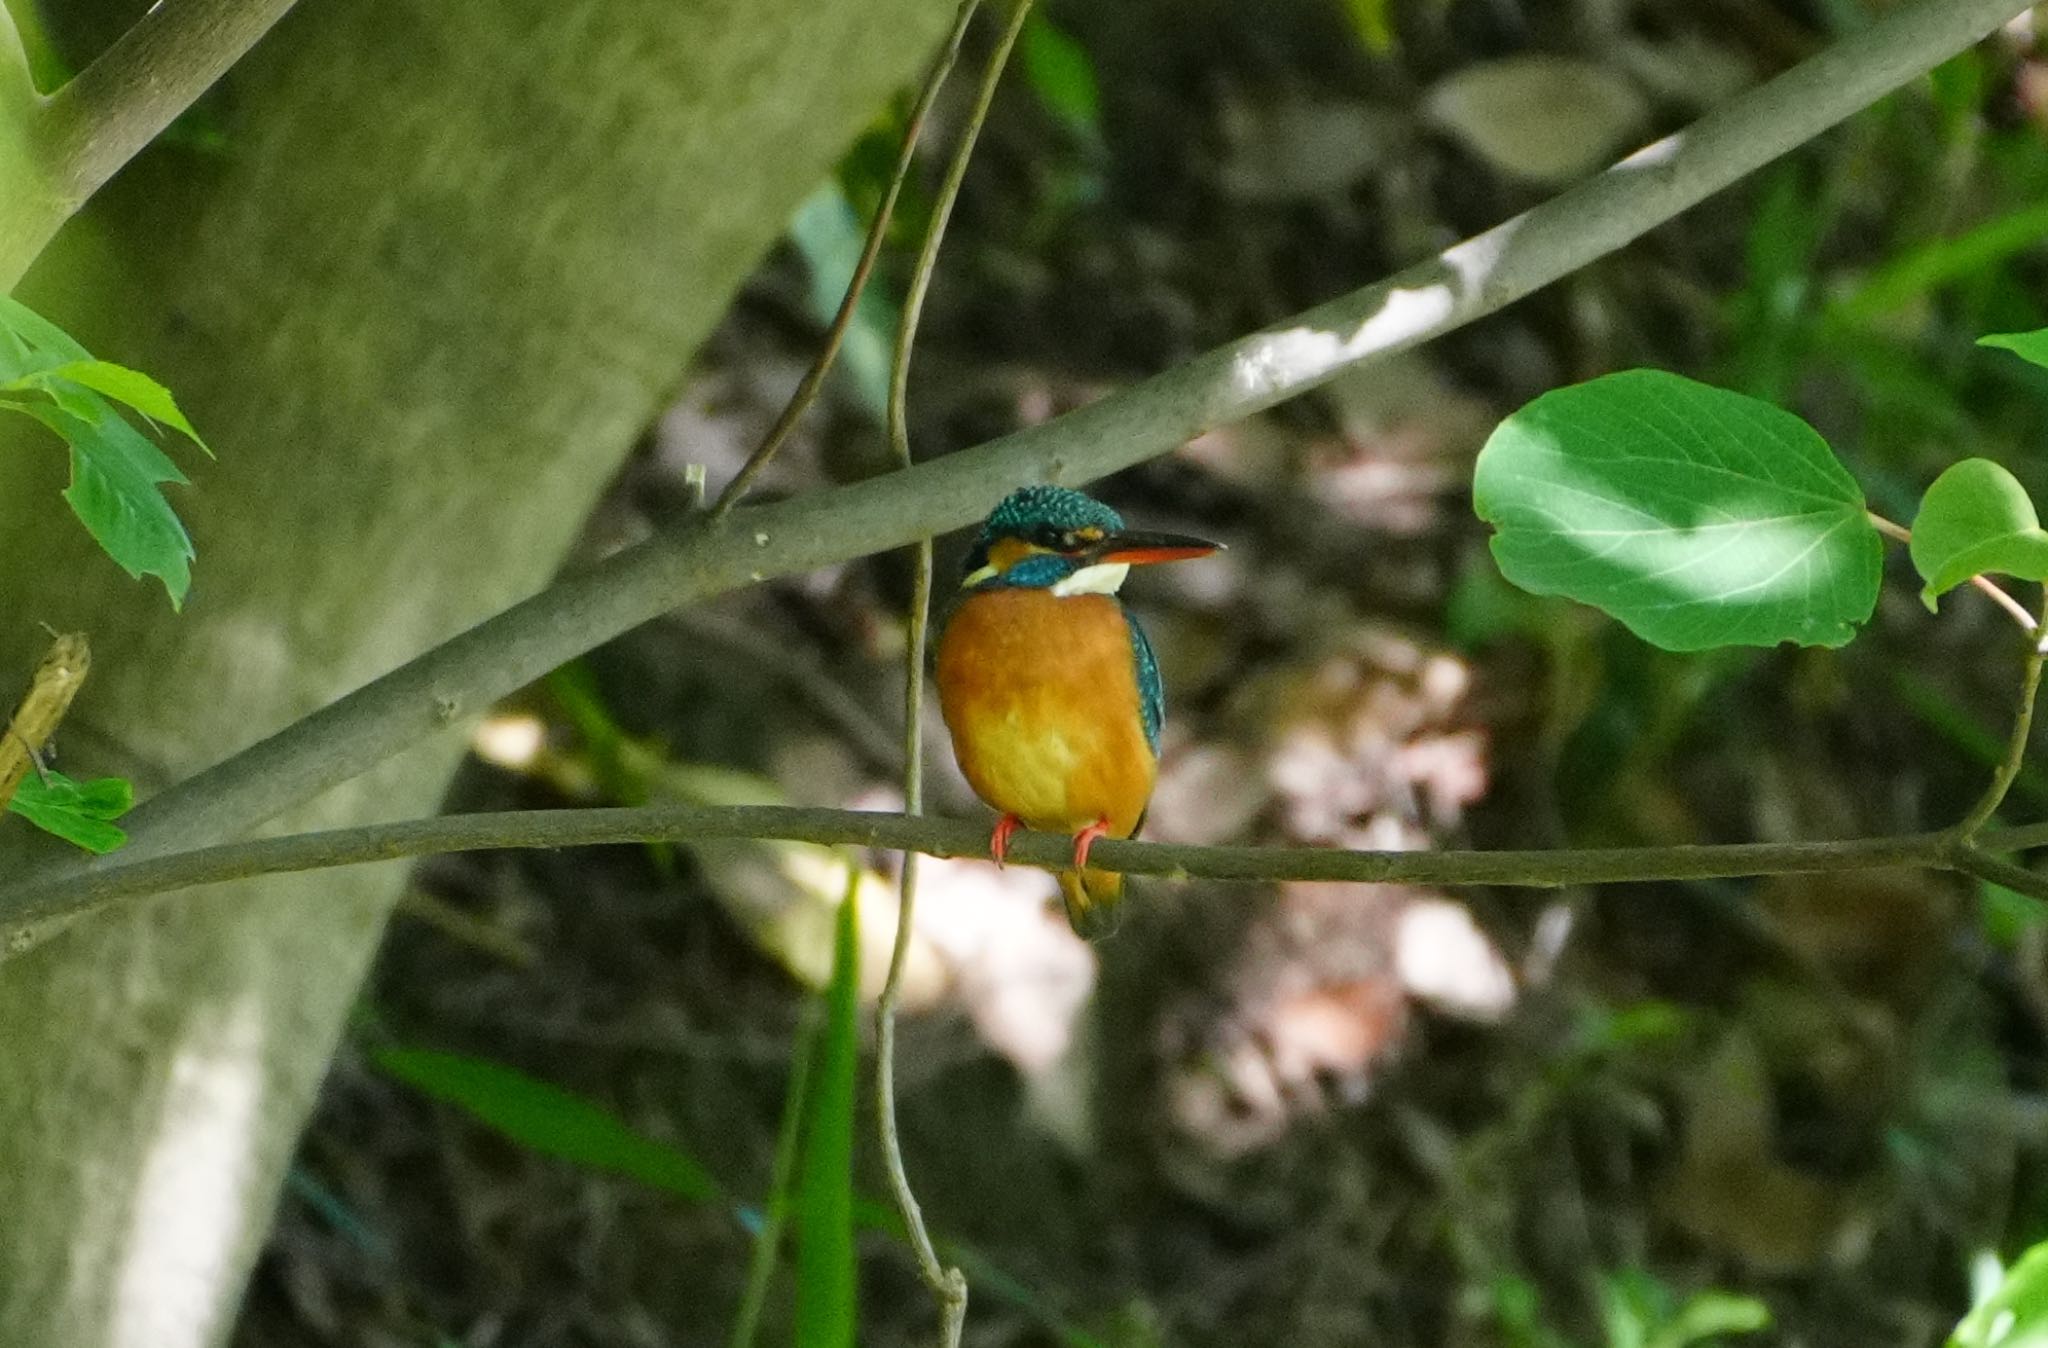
[961,488,1221,596]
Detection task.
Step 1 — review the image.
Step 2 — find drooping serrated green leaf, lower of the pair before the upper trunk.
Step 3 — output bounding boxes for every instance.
[25,395,193,608]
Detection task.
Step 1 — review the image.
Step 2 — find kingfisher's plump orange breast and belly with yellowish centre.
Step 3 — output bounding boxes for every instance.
[936,588,1157,838]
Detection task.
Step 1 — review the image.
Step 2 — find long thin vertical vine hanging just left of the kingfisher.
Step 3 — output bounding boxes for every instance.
[874,0,1032,1348]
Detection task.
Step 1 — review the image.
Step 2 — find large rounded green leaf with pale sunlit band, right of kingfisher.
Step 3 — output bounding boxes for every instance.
[1473,371,1884,651]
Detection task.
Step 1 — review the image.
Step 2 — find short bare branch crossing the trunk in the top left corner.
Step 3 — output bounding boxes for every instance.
[43,0,293,213]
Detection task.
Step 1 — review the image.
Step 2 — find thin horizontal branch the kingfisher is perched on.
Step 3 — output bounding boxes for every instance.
[0,805,2048,932]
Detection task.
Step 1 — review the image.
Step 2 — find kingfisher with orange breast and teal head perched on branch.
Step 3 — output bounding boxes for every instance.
[934,486,1221,938]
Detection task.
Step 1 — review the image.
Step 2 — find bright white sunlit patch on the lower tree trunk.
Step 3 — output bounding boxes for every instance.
[106,998,266,1348]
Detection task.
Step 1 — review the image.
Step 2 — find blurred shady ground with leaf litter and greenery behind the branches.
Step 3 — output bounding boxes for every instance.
[228,0,2048,1348]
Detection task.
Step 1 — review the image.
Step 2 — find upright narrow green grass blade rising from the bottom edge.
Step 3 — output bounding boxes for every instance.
[797,871,860,1348]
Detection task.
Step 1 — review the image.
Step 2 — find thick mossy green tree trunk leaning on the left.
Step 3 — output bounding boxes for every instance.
[0,0,950,1348]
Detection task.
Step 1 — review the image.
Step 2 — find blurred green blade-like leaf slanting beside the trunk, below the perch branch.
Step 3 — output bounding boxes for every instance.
[375,1049,719,1200]
